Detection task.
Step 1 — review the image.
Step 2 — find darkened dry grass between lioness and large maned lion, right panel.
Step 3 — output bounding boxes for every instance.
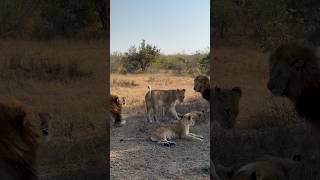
[211,48,320,180]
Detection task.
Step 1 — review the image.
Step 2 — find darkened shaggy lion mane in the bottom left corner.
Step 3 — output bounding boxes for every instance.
[0,100,40,180]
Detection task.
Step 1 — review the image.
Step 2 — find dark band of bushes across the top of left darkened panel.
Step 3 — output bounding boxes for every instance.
[0,0,108,40]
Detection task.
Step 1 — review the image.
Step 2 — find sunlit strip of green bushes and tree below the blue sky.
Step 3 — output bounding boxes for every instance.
[110,40,210,75]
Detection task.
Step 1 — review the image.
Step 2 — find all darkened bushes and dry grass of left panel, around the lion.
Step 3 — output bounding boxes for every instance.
[0,0,109,180]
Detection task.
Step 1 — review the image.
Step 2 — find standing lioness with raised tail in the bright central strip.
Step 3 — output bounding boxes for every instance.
[145,85,186,122]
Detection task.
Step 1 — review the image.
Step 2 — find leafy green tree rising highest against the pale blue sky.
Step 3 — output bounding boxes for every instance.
[123,40,160,72]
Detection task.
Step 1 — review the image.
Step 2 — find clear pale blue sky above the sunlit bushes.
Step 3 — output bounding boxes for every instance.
[110,0,210,54]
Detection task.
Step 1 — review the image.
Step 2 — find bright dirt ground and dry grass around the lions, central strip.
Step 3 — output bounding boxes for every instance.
[110,73,210,180]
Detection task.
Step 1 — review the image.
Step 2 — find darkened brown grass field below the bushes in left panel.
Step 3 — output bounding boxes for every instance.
[0,40,107,180]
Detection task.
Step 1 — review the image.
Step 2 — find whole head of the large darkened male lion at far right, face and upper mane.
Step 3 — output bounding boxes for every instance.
[268,44,318,101]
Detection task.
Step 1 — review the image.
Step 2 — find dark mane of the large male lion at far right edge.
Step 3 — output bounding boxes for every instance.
[270,43,320,127]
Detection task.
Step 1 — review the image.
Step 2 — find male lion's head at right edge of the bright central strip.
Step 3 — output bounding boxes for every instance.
[193,75,210,102]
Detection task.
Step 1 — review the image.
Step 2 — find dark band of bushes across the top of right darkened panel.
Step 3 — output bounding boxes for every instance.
[211,0,320,50]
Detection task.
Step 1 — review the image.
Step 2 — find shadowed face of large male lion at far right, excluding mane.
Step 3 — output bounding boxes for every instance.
[268,61,290,96]
